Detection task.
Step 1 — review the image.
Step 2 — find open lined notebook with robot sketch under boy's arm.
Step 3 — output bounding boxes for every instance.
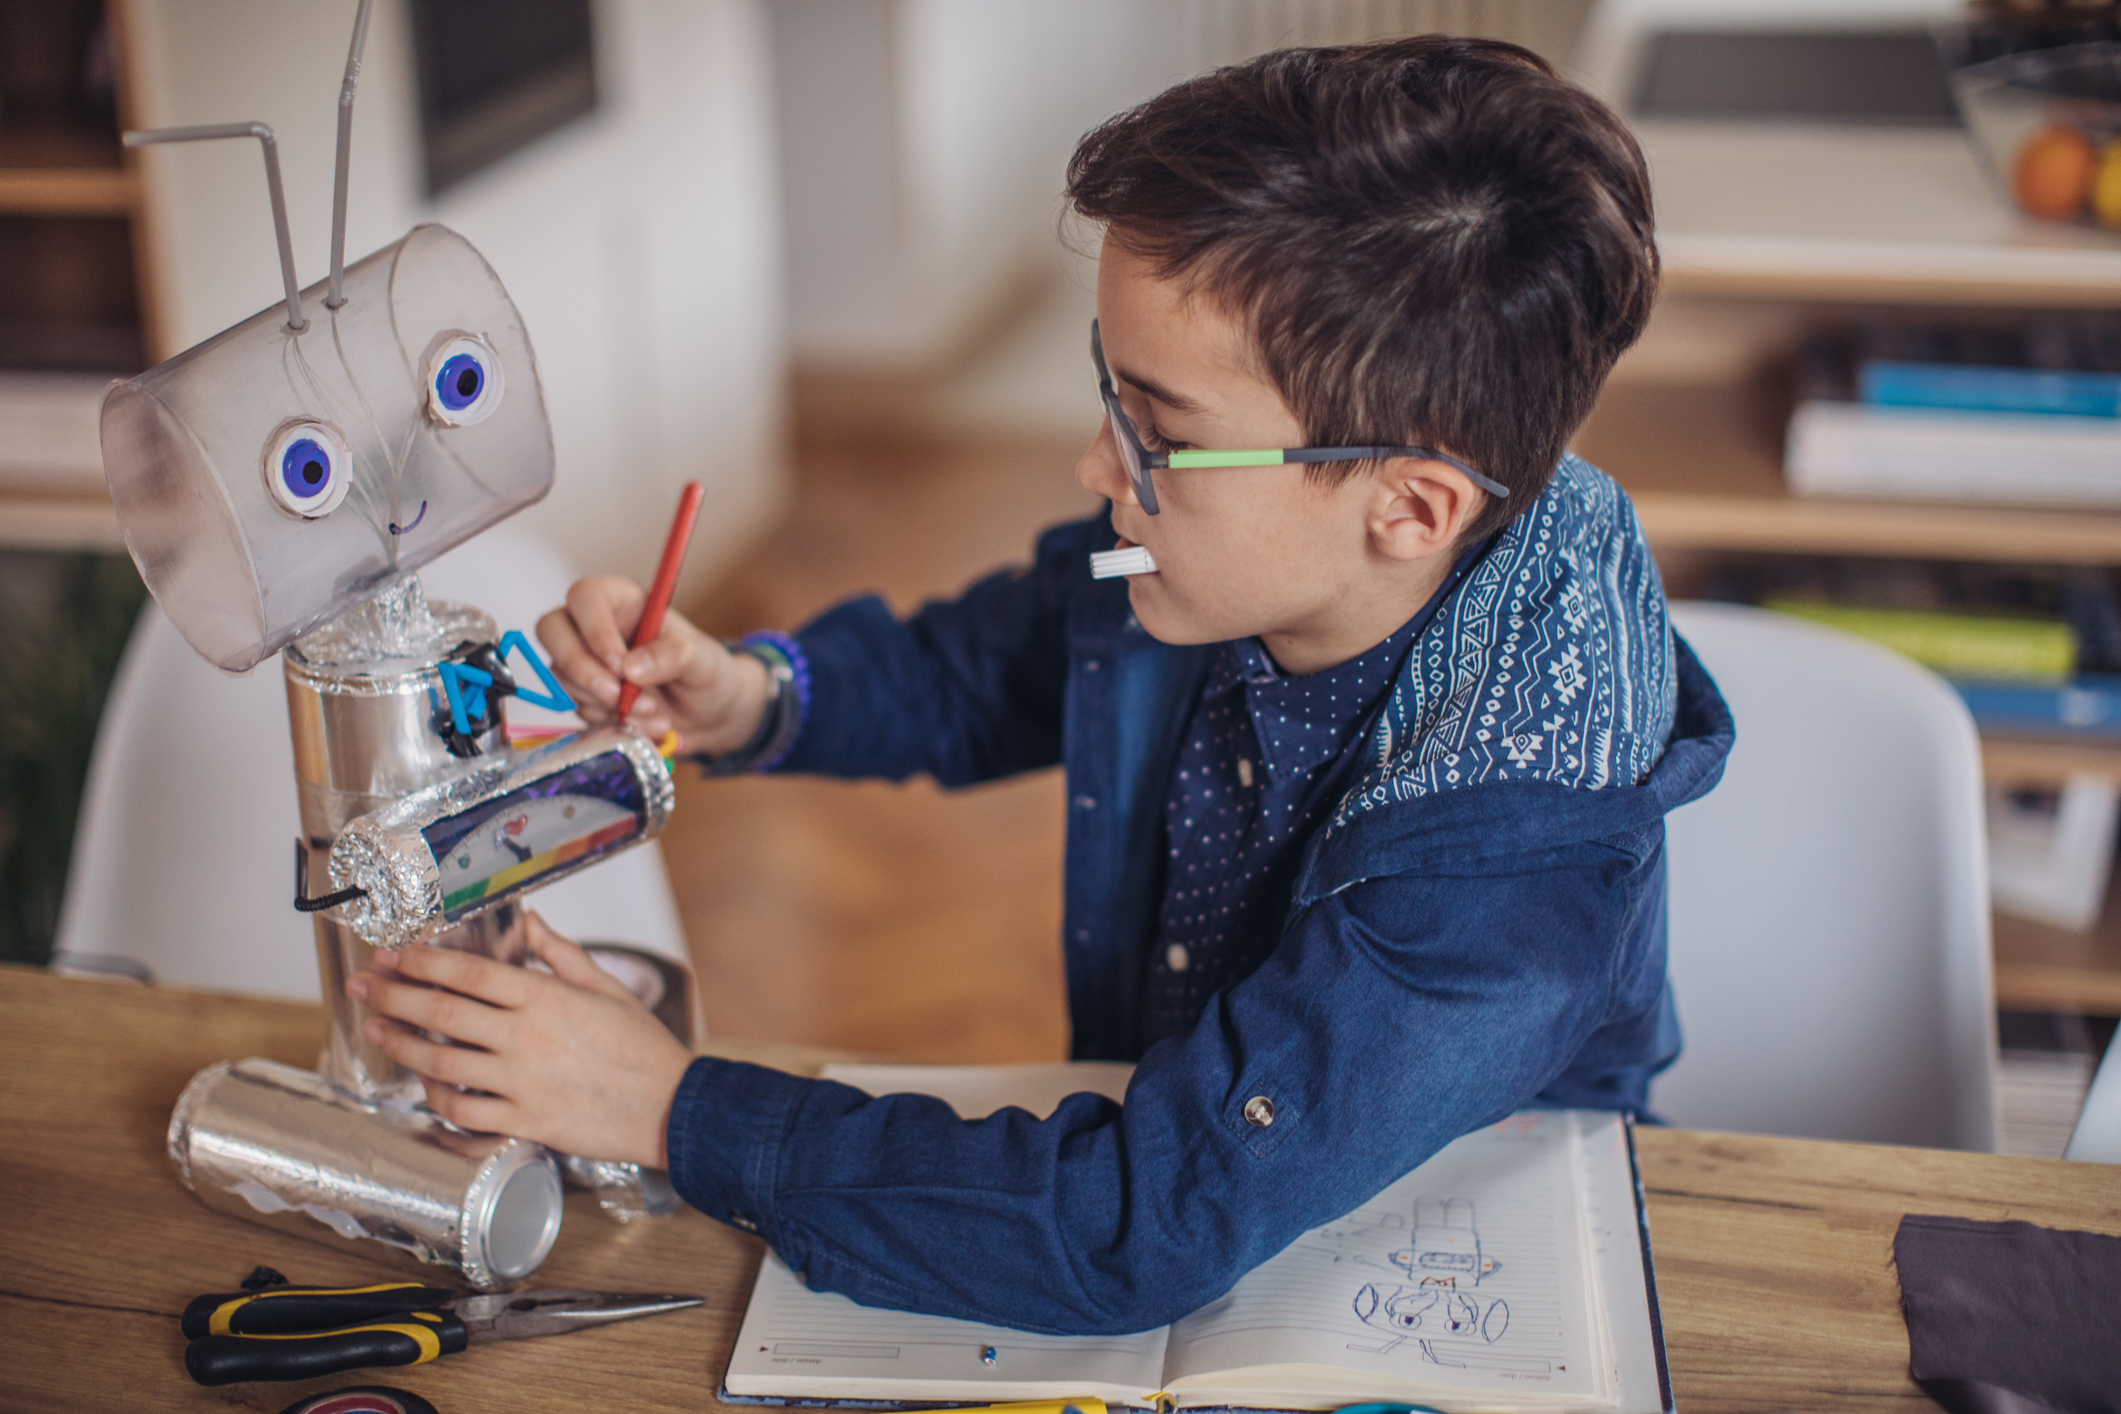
[723,1064,1671,1414]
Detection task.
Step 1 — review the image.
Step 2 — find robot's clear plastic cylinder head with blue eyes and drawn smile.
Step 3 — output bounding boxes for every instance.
[102,225,554,672]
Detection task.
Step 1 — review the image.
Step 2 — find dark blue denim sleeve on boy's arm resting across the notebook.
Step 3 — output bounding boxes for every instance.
[668,827,1663,1333]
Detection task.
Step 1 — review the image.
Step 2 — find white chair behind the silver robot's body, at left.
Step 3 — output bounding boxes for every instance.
[53,526,689,1001]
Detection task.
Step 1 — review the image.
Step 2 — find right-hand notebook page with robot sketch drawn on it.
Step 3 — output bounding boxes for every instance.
[1164,1111,1612,1410]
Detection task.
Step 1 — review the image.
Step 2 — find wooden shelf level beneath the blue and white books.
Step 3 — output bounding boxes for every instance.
[1574,384,2121,564]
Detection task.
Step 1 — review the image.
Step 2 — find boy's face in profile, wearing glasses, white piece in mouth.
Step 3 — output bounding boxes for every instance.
[1075,240,1447,672]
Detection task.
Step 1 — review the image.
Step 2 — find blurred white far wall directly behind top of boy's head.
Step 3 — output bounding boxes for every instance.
[772,0,1594,371]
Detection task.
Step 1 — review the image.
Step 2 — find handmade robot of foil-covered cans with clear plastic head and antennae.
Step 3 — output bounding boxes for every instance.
[102,0,689,1287]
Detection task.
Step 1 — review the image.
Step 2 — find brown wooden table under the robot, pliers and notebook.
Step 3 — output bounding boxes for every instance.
[0,969,2121,1414]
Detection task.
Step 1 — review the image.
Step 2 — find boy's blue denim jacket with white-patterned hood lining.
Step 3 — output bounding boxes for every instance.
[668,458,1731,1333]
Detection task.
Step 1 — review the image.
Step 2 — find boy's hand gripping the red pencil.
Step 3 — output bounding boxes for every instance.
[537,577,770,755]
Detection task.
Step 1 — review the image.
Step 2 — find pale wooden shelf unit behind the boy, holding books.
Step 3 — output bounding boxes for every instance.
[1576,125,2121,1015]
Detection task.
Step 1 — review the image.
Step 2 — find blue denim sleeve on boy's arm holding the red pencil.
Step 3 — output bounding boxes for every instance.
[776,517,1109,786]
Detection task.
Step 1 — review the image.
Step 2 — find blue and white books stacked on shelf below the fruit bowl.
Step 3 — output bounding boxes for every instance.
[1784,322,2121,507]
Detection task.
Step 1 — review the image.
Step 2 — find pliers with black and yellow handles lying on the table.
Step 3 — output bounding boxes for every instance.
[185,1280,704,1384]
